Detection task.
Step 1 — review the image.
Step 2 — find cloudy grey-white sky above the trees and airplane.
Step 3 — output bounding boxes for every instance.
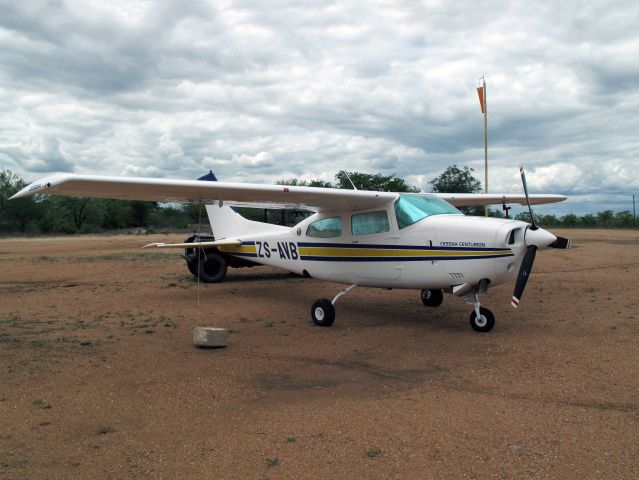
[0,0,639,214]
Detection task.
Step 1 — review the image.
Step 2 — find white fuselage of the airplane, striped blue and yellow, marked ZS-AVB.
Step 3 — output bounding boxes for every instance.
[220,196,540,289]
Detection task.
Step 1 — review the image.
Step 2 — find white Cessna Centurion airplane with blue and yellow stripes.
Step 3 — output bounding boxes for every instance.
[12,169,570,332]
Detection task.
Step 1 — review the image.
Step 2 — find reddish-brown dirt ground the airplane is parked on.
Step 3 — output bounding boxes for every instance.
[0,230,639,479]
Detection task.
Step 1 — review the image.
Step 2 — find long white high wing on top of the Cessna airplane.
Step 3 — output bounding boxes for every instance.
[11,173,566,211]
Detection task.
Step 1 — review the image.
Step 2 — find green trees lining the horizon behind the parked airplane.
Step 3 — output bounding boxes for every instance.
[0,165,635,234]
